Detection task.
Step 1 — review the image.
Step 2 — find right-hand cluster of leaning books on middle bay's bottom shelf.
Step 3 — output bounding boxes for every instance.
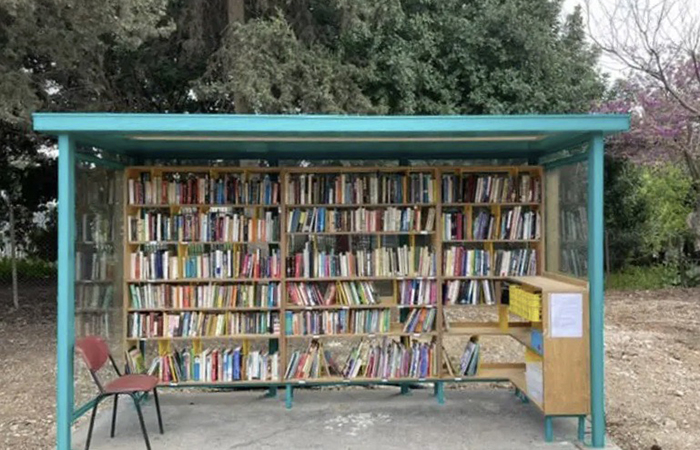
[342,338,439,379]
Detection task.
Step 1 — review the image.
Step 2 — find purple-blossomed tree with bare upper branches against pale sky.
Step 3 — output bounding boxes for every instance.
[586,0,700,248]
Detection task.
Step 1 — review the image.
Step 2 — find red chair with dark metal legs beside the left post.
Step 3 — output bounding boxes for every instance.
[75,336,163,450]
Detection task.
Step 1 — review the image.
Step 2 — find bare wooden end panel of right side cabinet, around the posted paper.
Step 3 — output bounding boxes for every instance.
[542,281,590,415]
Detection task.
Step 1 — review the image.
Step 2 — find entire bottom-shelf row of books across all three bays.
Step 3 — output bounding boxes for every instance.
[126,337,480,383]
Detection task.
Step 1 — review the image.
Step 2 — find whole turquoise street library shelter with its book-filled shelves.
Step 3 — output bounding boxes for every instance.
[34,113,629,450]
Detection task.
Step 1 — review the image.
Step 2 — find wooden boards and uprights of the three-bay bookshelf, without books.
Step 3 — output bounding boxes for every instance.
[123,166,592,412]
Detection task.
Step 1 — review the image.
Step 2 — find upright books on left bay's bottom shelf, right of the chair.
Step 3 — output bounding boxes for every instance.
[149,347,279,383]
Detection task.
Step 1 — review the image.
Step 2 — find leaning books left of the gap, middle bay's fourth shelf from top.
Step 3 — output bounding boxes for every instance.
[287,281,379,306]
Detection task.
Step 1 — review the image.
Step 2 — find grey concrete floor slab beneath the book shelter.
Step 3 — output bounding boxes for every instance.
[73,388,616,450]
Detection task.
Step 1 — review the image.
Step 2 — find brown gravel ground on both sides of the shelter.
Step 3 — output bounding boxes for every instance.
[0,286,700,450]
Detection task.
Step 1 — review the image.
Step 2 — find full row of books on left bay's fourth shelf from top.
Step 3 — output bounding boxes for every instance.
[129,283,281,309]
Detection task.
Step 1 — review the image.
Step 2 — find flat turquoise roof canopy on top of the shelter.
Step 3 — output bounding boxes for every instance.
[34,113,629,159]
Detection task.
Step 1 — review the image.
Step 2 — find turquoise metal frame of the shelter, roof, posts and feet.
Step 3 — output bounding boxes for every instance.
[34,113,629,450]
